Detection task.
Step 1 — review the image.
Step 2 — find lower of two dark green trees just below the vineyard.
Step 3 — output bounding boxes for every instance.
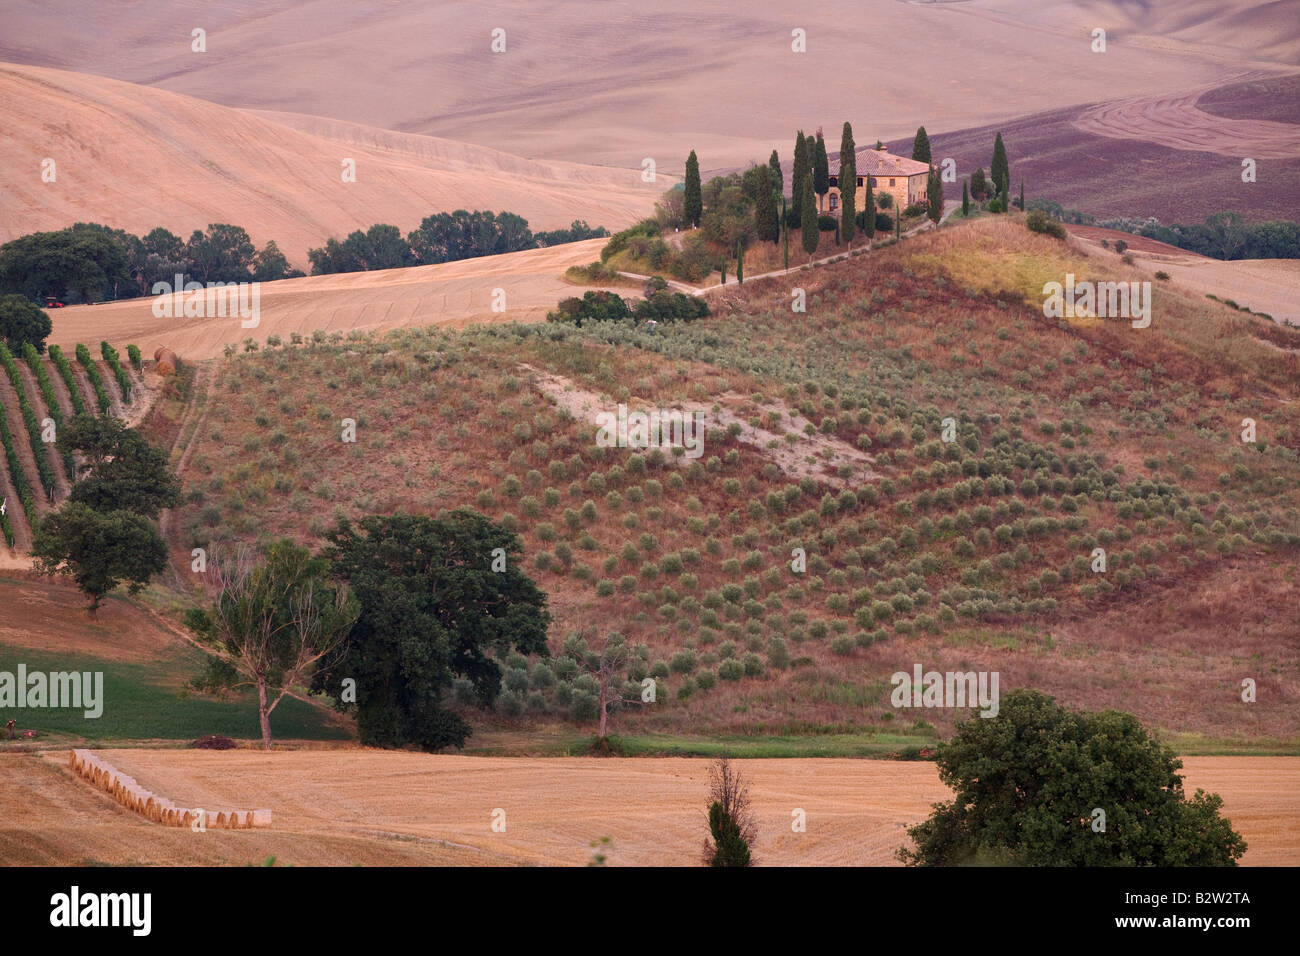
[31,501,166,618]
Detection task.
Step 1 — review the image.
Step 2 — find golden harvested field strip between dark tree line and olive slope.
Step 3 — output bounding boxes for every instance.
[49,239,607,360]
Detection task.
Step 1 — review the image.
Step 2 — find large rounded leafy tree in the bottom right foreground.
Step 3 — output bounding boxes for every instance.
[898,691,1245,866]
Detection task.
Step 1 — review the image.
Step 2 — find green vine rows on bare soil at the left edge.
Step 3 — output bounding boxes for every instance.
[0,343,140,551]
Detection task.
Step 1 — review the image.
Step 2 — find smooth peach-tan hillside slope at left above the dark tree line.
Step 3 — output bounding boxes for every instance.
[0,64,671,261]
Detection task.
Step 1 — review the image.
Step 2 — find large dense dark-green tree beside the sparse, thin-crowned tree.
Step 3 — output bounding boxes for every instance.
[321,510,550,750]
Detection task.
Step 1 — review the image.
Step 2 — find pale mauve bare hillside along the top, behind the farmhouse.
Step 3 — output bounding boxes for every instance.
[0,0,1300,172]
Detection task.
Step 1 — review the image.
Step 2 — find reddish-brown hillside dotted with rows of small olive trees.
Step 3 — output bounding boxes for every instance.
[147,217,1300,743]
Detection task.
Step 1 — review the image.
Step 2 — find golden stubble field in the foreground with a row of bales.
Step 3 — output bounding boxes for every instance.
[0,749,1300,866]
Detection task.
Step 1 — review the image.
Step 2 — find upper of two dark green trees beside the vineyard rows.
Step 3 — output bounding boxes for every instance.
[55,415,181,519]
